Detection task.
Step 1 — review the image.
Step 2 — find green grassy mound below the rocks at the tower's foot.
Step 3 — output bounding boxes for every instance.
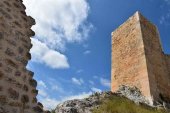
[93,96,166,113]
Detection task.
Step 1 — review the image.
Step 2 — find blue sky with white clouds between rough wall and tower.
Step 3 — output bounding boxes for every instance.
[24,0,170,109]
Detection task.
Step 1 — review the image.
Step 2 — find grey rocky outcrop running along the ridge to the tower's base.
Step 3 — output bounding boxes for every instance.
[55,86,153,113]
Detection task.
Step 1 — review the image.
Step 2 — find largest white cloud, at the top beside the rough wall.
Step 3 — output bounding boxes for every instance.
[23,0,93,50]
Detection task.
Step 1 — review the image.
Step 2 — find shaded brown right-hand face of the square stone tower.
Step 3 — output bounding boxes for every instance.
[140,16,170,100]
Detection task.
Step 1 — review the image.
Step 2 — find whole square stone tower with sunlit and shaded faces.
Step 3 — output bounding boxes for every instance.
[111,12,170,104]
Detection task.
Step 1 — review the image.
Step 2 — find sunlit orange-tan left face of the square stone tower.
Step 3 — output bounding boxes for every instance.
[111,12,151,99]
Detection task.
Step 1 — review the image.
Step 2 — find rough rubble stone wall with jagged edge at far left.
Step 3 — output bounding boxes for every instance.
[0,0,43,113]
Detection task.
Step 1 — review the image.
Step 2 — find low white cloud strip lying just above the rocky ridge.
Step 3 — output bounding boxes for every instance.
[40,92,92,110]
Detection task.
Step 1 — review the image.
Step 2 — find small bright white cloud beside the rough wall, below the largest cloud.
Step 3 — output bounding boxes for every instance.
[30,38,69,69]
